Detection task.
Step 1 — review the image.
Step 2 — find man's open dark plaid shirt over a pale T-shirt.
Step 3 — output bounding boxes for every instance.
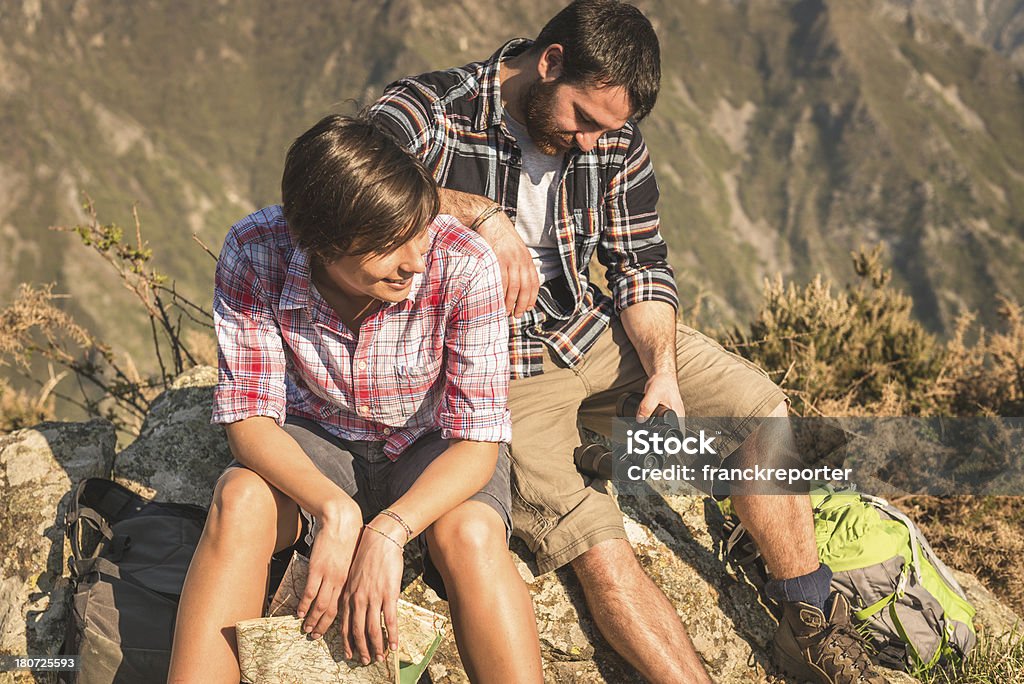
[371,39,679,378]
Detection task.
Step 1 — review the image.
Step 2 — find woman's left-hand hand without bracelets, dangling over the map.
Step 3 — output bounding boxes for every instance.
[296,499,362,639]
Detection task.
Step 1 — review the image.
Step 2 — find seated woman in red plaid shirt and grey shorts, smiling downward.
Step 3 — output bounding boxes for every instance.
[169,116,542,683]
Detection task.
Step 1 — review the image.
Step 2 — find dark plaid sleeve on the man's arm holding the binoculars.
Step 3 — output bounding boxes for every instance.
[597,126,679,311]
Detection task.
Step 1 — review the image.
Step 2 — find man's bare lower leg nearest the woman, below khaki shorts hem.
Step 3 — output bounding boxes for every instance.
[572,539,711,684]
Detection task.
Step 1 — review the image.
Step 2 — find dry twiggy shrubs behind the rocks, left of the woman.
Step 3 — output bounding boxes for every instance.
[0,199,216,434]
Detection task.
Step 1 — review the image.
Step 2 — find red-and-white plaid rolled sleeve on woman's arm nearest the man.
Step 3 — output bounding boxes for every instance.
[438,249,512,442]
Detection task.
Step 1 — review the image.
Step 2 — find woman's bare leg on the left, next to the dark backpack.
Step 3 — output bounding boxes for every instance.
[168,468,301,684]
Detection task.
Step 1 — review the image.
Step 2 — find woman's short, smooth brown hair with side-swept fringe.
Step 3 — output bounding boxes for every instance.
[281,115,440,263]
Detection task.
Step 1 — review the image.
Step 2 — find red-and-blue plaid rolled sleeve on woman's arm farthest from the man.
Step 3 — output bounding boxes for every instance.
[211,233,286,424]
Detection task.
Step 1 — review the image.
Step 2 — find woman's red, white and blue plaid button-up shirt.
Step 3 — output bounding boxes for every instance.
[213,206,512,460]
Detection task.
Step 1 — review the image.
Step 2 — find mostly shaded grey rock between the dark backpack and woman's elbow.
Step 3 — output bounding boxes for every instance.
[114,367,231,506]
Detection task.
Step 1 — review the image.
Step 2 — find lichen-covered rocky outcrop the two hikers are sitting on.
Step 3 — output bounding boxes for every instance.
[0,369,1017,684]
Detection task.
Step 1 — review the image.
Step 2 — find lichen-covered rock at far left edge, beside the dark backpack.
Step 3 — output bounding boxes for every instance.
[0,420,117,655]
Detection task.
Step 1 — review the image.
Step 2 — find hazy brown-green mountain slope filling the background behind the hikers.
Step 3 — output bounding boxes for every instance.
[0,0,1024,374]
